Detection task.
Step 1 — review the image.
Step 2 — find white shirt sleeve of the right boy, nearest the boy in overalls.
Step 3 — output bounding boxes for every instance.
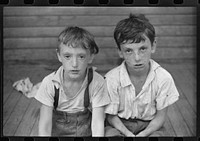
[105,75,119,115]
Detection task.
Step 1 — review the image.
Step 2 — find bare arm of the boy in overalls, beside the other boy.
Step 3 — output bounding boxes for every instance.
[91,107,105,137]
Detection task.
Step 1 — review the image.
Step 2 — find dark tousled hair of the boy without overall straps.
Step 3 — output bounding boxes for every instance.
[114,14,155,50]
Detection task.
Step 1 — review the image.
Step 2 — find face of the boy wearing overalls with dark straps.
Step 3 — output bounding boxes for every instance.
[57,43,94,81]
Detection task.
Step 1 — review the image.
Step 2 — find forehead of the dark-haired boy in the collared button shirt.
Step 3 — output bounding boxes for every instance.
[121,37,151,49]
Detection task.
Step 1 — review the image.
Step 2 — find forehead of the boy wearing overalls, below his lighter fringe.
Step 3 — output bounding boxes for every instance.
[59,43,90,54]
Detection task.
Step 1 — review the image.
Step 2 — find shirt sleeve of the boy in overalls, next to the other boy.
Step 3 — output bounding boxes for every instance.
[92,81,110,108]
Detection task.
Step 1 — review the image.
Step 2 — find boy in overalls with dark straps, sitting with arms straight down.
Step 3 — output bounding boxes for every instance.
[35,27,110,136]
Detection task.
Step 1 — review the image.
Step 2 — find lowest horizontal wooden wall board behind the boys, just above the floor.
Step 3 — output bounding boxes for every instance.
[4,48,195,64]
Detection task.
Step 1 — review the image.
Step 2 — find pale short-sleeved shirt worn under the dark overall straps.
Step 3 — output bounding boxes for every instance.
[35,66,110,113]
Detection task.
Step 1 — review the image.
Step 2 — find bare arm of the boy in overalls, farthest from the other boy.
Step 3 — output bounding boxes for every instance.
[39,104,53,136]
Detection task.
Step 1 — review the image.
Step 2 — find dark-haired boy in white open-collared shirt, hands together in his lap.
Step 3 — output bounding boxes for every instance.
[105,14,179,136]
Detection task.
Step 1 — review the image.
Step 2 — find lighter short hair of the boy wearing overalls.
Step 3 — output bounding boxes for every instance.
[58,26,99,54]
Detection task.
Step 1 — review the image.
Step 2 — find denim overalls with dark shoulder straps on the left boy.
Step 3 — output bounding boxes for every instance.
[52,68,93,136]
